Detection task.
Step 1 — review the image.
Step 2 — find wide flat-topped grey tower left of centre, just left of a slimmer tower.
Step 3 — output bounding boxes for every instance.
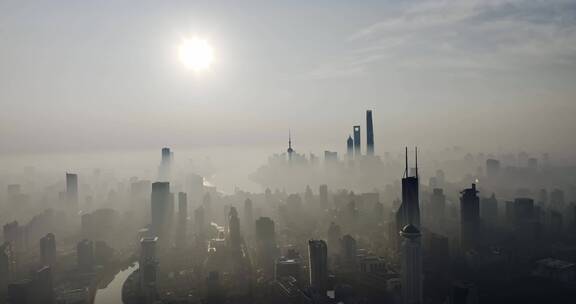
[150,182,170,238]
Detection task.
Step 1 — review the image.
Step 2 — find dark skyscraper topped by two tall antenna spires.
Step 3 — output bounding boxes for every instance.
[397,148,420,230]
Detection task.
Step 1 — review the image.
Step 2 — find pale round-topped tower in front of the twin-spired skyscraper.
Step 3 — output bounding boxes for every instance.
[400,225,422,304]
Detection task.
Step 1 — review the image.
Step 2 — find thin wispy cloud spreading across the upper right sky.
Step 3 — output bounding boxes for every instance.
[308,0,576,78]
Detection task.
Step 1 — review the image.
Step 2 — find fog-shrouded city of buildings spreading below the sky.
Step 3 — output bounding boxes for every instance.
[0,110,576,304]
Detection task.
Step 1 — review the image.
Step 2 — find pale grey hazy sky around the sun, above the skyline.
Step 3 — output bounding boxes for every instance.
[0,0,576,153]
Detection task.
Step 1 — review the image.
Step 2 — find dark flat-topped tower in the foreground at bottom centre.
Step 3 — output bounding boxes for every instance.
[308,240,328,295]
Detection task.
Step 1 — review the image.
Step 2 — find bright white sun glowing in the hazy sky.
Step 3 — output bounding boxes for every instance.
[178,37,214,72]
